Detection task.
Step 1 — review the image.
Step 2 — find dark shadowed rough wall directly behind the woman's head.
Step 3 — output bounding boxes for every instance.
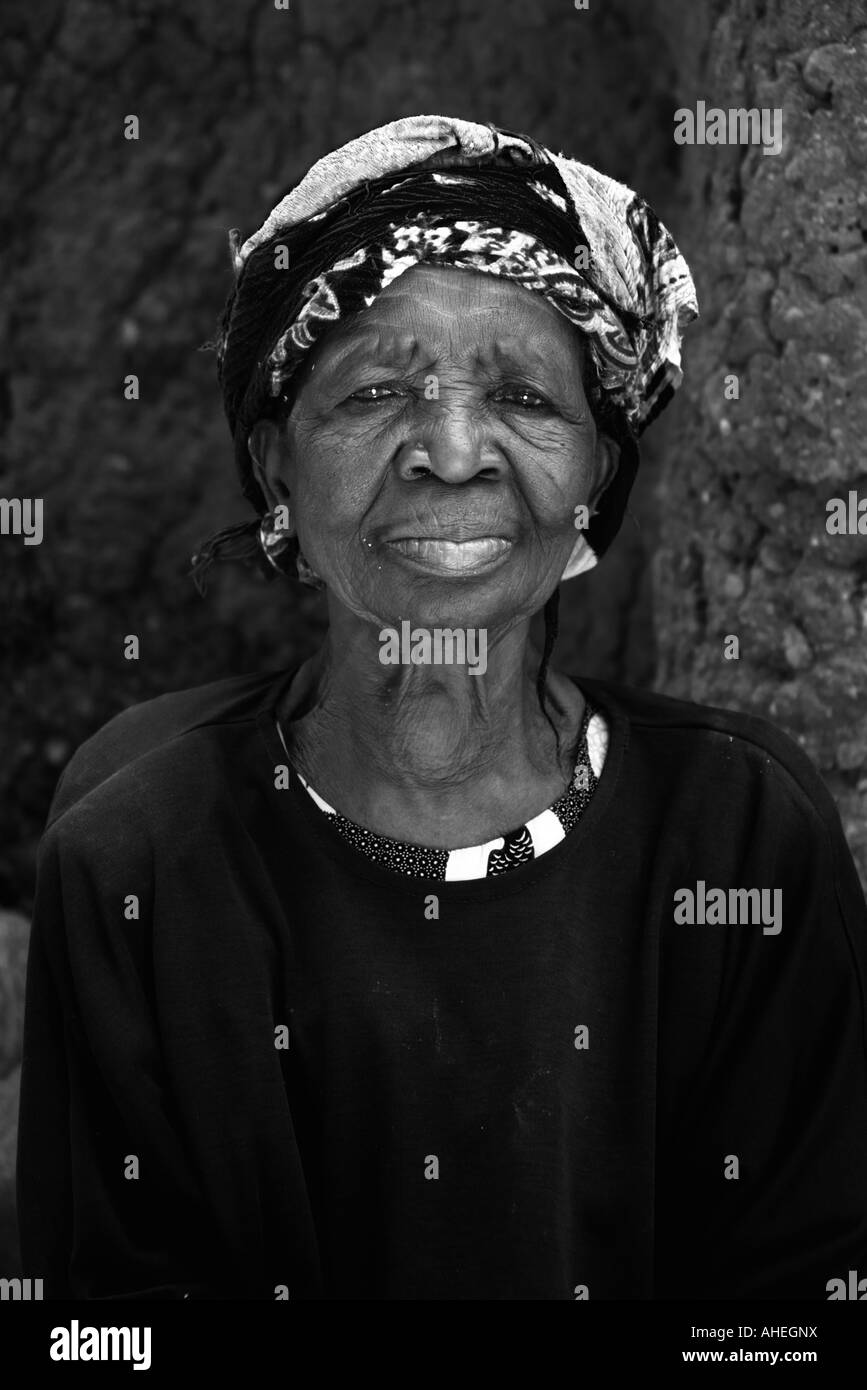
[0,0,674,910]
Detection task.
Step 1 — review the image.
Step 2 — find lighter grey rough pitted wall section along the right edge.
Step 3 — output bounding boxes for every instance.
[654,0,867,883]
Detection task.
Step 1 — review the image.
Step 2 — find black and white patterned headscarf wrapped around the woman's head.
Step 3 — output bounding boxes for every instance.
[195,115,697,589]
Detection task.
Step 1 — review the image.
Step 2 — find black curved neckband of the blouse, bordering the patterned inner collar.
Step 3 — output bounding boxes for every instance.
[256,667,629,902]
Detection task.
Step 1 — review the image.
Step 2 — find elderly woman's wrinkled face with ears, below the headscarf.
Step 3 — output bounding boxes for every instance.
[251,265,616,631]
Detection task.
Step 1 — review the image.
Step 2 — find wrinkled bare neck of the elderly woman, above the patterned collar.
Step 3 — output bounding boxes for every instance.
[279,627,584,848]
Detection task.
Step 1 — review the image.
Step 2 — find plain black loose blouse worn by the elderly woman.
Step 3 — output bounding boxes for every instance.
[18,671,867,1300]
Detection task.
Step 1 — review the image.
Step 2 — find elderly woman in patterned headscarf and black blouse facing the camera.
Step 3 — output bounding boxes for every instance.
[19,117,867,1300]
